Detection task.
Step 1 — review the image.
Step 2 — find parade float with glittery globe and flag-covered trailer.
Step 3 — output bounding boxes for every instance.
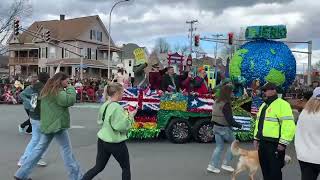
[121,26,296,143]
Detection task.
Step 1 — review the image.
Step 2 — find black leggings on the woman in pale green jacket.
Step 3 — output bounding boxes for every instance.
[82,138,131,180]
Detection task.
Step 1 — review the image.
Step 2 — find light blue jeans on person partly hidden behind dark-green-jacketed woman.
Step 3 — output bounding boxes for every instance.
[19,119,41,164]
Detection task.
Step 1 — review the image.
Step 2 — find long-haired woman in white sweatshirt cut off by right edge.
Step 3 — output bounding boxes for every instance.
[294,87,320,180]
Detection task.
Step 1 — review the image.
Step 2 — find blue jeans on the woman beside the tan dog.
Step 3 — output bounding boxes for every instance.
[210,125,235,168]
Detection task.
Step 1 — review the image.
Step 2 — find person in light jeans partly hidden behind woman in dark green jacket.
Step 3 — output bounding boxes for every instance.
[18,72,49,167]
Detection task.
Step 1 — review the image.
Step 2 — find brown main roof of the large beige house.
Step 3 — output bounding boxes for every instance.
[18,15,114,44]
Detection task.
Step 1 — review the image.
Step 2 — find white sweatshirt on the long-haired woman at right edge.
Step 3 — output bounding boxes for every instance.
[294,110,320,164]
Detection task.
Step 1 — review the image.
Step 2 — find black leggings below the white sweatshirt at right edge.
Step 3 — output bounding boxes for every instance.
[299,161,320,180]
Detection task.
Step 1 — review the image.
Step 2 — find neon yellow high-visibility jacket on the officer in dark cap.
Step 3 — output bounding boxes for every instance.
[254,98,296,145]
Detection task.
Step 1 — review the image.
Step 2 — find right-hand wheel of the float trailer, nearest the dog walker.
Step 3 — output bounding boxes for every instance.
[193,119,214,143]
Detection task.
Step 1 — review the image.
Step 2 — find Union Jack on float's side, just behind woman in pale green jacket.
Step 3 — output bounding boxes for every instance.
[120,88,160,111]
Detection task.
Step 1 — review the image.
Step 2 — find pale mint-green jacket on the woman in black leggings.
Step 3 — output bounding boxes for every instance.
[97,101,133,143]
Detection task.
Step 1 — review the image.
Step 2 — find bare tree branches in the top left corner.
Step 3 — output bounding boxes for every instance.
[0,0,32,54]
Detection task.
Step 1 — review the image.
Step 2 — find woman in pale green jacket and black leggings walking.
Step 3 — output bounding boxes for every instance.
[82,83,137,180]
